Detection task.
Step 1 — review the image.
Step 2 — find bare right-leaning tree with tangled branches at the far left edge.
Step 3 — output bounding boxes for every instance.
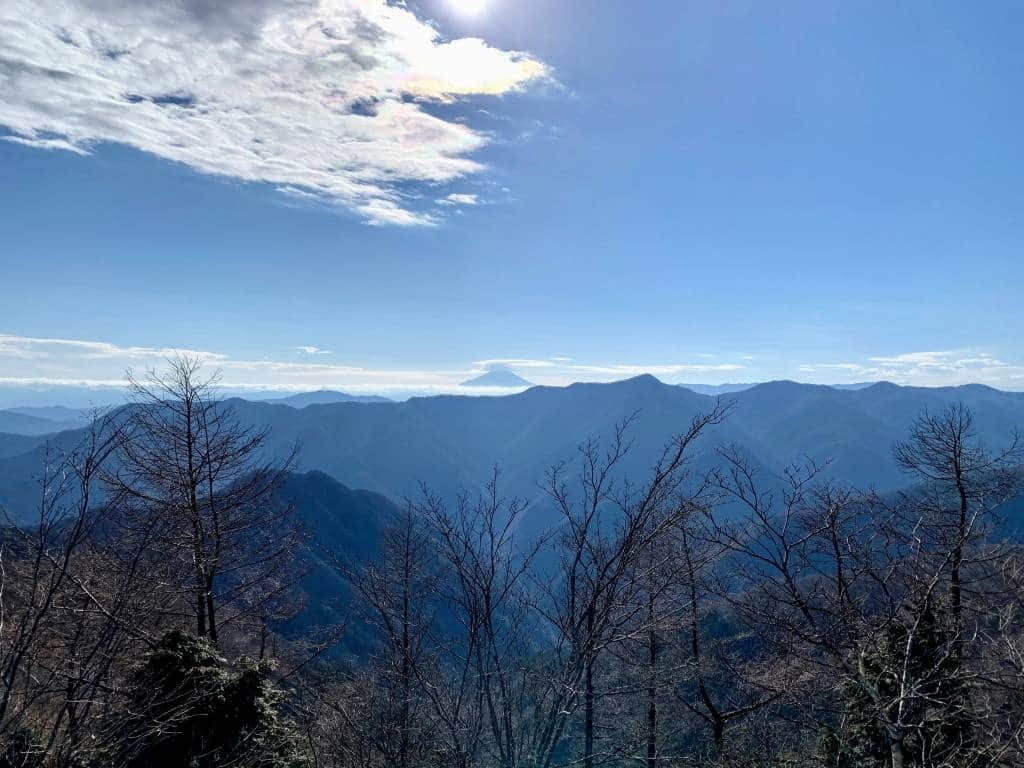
[0,414,160,763]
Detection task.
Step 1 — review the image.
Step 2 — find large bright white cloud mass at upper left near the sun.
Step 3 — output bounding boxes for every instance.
[0,0,550,225]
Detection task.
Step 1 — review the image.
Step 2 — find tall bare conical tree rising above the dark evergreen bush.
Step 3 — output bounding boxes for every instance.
[104,356,301,644]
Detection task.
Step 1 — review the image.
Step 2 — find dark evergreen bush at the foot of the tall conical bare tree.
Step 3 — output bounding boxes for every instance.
[112,631,305,768]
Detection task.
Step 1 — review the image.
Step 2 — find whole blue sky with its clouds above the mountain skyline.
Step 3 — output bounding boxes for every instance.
[0,0,1024,391]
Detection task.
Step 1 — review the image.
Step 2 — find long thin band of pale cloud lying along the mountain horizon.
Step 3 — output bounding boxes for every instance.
[8,334,1024,393]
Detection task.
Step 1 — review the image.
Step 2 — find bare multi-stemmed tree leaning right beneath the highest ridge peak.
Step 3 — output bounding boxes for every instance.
[532,402,729,768]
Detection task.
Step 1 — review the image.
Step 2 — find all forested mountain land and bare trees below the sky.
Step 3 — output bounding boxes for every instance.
[0,357,1024,768]
